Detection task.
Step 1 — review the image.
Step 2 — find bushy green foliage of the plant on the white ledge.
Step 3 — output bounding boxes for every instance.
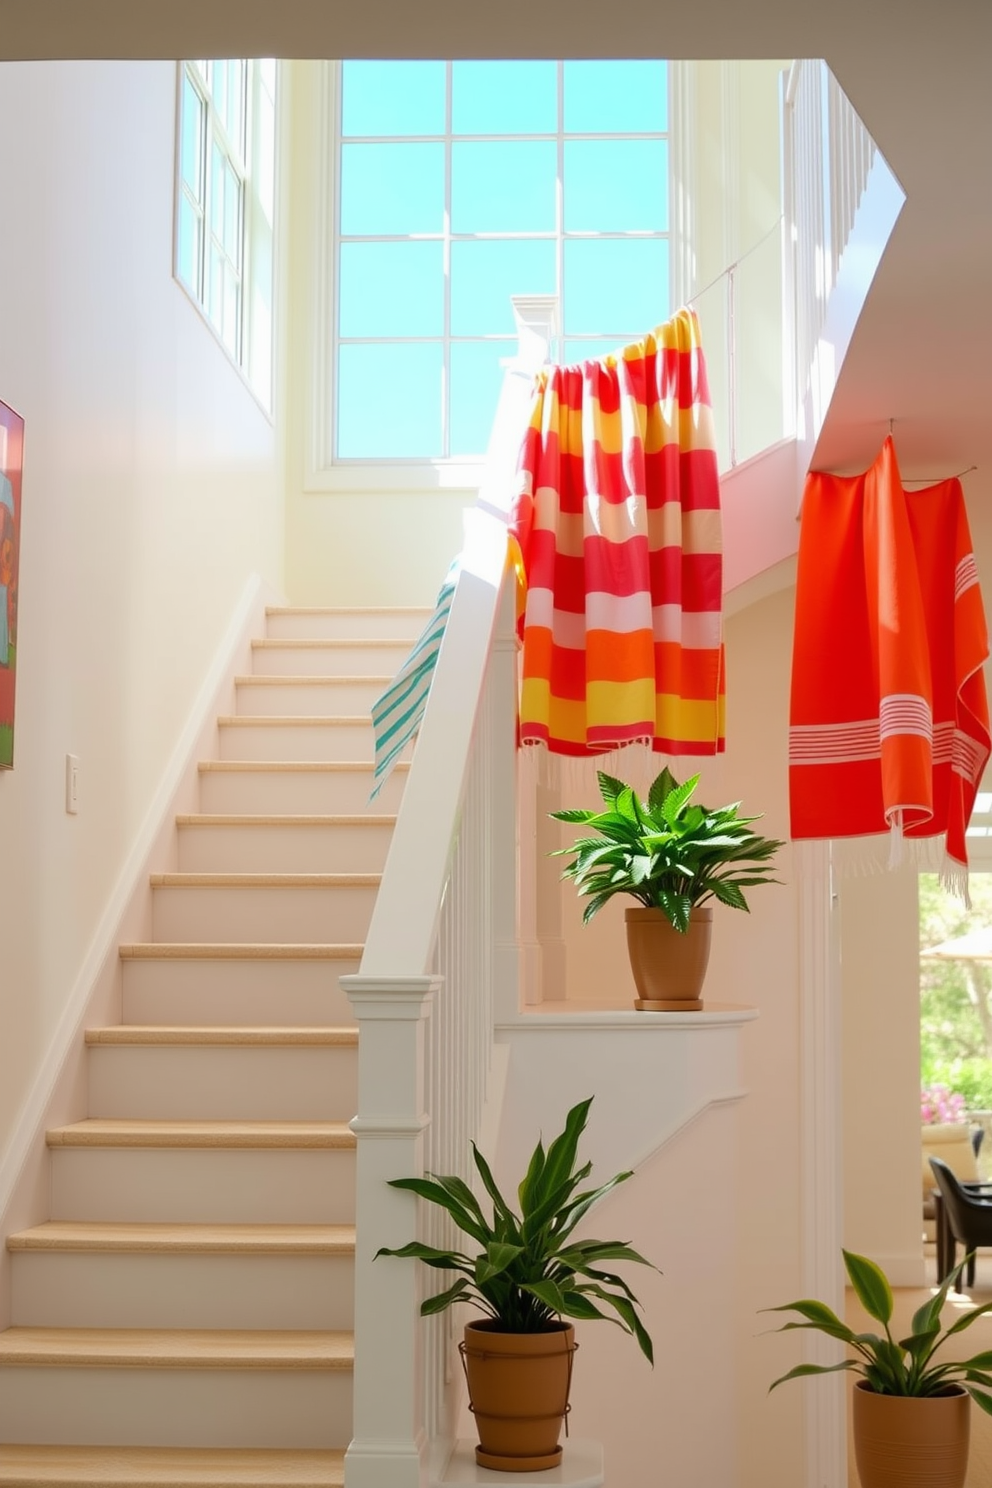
[552,766,784,934]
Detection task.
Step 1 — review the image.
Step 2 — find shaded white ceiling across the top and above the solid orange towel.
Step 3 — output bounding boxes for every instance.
[7,0,992,494]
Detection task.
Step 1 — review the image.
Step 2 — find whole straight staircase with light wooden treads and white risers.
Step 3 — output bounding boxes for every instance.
[0,610,424,1488]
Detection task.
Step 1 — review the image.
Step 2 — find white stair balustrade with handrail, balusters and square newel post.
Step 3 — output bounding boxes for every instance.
[342,299,553,1488]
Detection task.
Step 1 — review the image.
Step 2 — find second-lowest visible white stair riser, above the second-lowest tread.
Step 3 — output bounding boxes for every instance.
[11,1251,354,1333]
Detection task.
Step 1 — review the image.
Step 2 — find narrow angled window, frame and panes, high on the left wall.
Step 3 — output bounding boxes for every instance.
[175,58,277,406]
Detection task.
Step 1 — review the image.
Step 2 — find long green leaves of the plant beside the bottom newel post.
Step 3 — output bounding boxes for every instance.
[376,1097,657,1363]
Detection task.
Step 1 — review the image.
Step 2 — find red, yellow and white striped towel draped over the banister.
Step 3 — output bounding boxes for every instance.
[510,310,724,756]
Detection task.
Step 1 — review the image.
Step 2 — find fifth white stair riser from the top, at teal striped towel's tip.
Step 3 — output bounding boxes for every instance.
[199,756,408,815]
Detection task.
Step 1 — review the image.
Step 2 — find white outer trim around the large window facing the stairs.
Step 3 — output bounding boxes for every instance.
[303,62,683,494]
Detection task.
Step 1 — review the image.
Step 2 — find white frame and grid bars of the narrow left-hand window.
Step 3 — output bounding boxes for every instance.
[173,58,280,415]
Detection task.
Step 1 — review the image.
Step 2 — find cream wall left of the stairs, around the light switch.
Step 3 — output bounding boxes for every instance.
[0,62,283,1165]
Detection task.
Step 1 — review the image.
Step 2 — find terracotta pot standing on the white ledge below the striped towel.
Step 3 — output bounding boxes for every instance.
[625,908,712,1013]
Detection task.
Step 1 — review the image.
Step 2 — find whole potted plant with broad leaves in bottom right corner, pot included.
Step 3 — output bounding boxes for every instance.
[766,1250,992,1488]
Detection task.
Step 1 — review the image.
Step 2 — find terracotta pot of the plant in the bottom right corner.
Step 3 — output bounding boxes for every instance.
[854,1379,971,1488]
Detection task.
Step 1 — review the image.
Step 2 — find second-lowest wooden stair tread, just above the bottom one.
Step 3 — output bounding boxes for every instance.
[0,1327,354,1369]
